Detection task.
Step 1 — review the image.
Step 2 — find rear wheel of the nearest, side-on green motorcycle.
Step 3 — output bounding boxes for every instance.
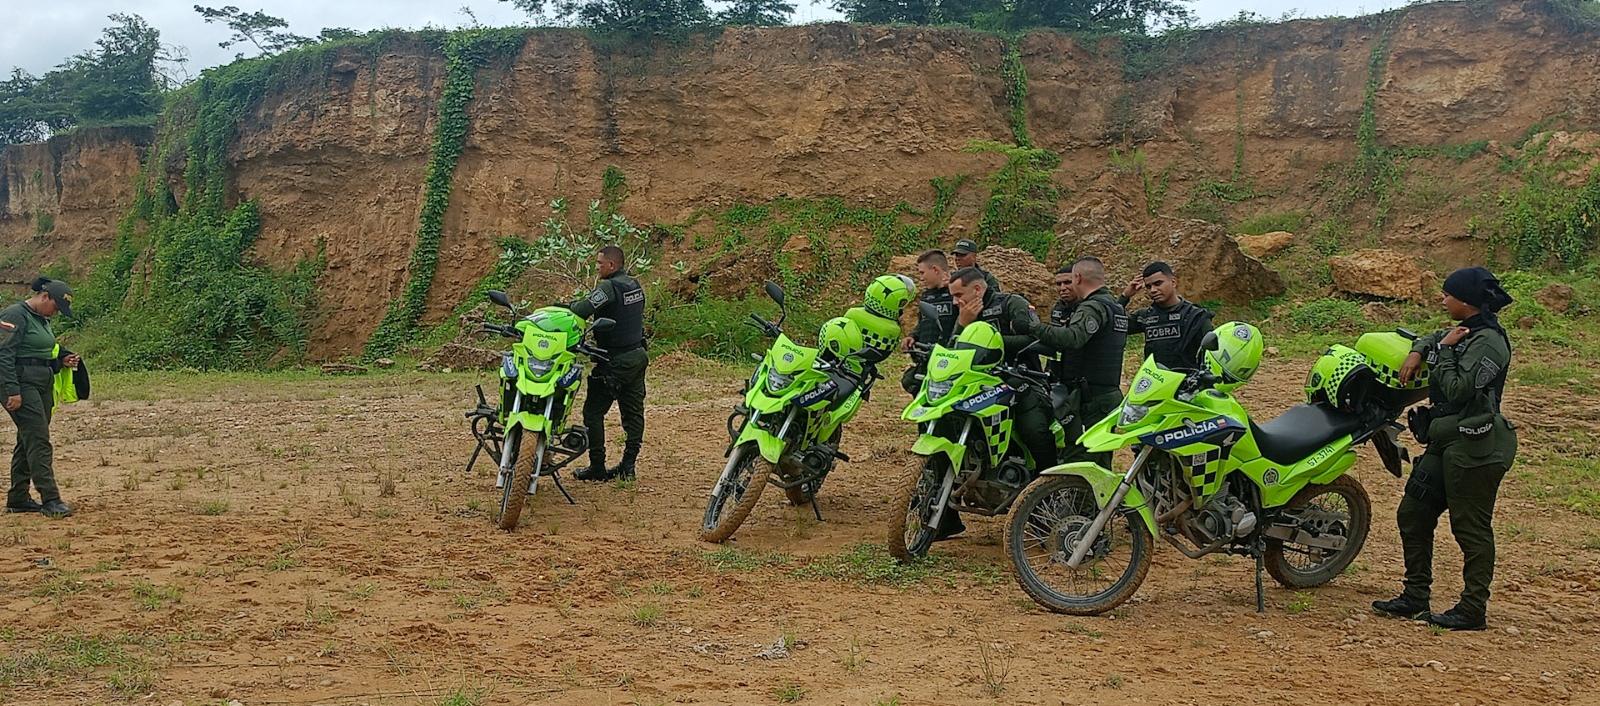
[1262,475,1373,589]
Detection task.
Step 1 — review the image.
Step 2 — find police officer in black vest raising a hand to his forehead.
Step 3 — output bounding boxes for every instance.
[1117,261,1211,370]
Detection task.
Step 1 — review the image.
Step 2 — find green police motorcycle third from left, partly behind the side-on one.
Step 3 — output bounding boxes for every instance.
[886,318,1072,562]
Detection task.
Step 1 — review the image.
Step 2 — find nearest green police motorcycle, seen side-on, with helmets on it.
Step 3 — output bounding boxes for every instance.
[1005,322,1427,615]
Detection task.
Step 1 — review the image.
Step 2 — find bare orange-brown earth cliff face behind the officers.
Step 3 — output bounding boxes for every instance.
[0,0,1600,357]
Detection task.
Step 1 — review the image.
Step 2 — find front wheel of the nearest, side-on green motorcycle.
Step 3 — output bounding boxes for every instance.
[1005,475,1152,615]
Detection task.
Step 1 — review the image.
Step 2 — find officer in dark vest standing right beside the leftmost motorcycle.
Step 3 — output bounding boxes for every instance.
[570,245,650,480]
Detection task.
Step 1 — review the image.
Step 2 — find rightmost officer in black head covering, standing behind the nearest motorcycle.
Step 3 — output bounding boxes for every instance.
[1373,267,1517,631]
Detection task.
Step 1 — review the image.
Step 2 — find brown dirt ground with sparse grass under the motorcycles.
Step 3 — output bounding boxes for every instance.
[0,348,1600,706]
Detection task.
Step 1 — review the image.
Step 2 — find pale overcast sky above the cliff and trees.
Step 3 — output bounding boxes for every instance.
[0,0,1405,74]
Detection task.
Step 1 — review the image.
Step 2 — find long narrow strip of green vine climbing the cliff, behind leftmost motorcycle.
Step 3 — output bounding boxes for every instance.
[363,29,526,359]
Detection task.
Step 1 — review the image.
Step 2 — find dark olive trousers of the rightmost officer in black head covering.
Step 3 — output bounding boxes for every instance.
[1395,448,1507,616]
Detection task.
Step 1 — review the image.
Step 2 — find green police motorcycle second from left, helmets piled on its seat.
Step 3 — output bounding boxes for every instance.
[701,282,882,543]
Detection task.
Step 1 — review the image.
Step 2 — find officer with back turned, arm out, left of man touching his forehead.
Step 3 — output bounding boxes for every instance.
[1034,258,1128,464]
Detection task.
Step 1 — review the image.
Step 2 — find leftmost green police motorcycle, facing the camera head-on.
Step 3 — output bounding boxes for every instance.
[467,291,616,530]
